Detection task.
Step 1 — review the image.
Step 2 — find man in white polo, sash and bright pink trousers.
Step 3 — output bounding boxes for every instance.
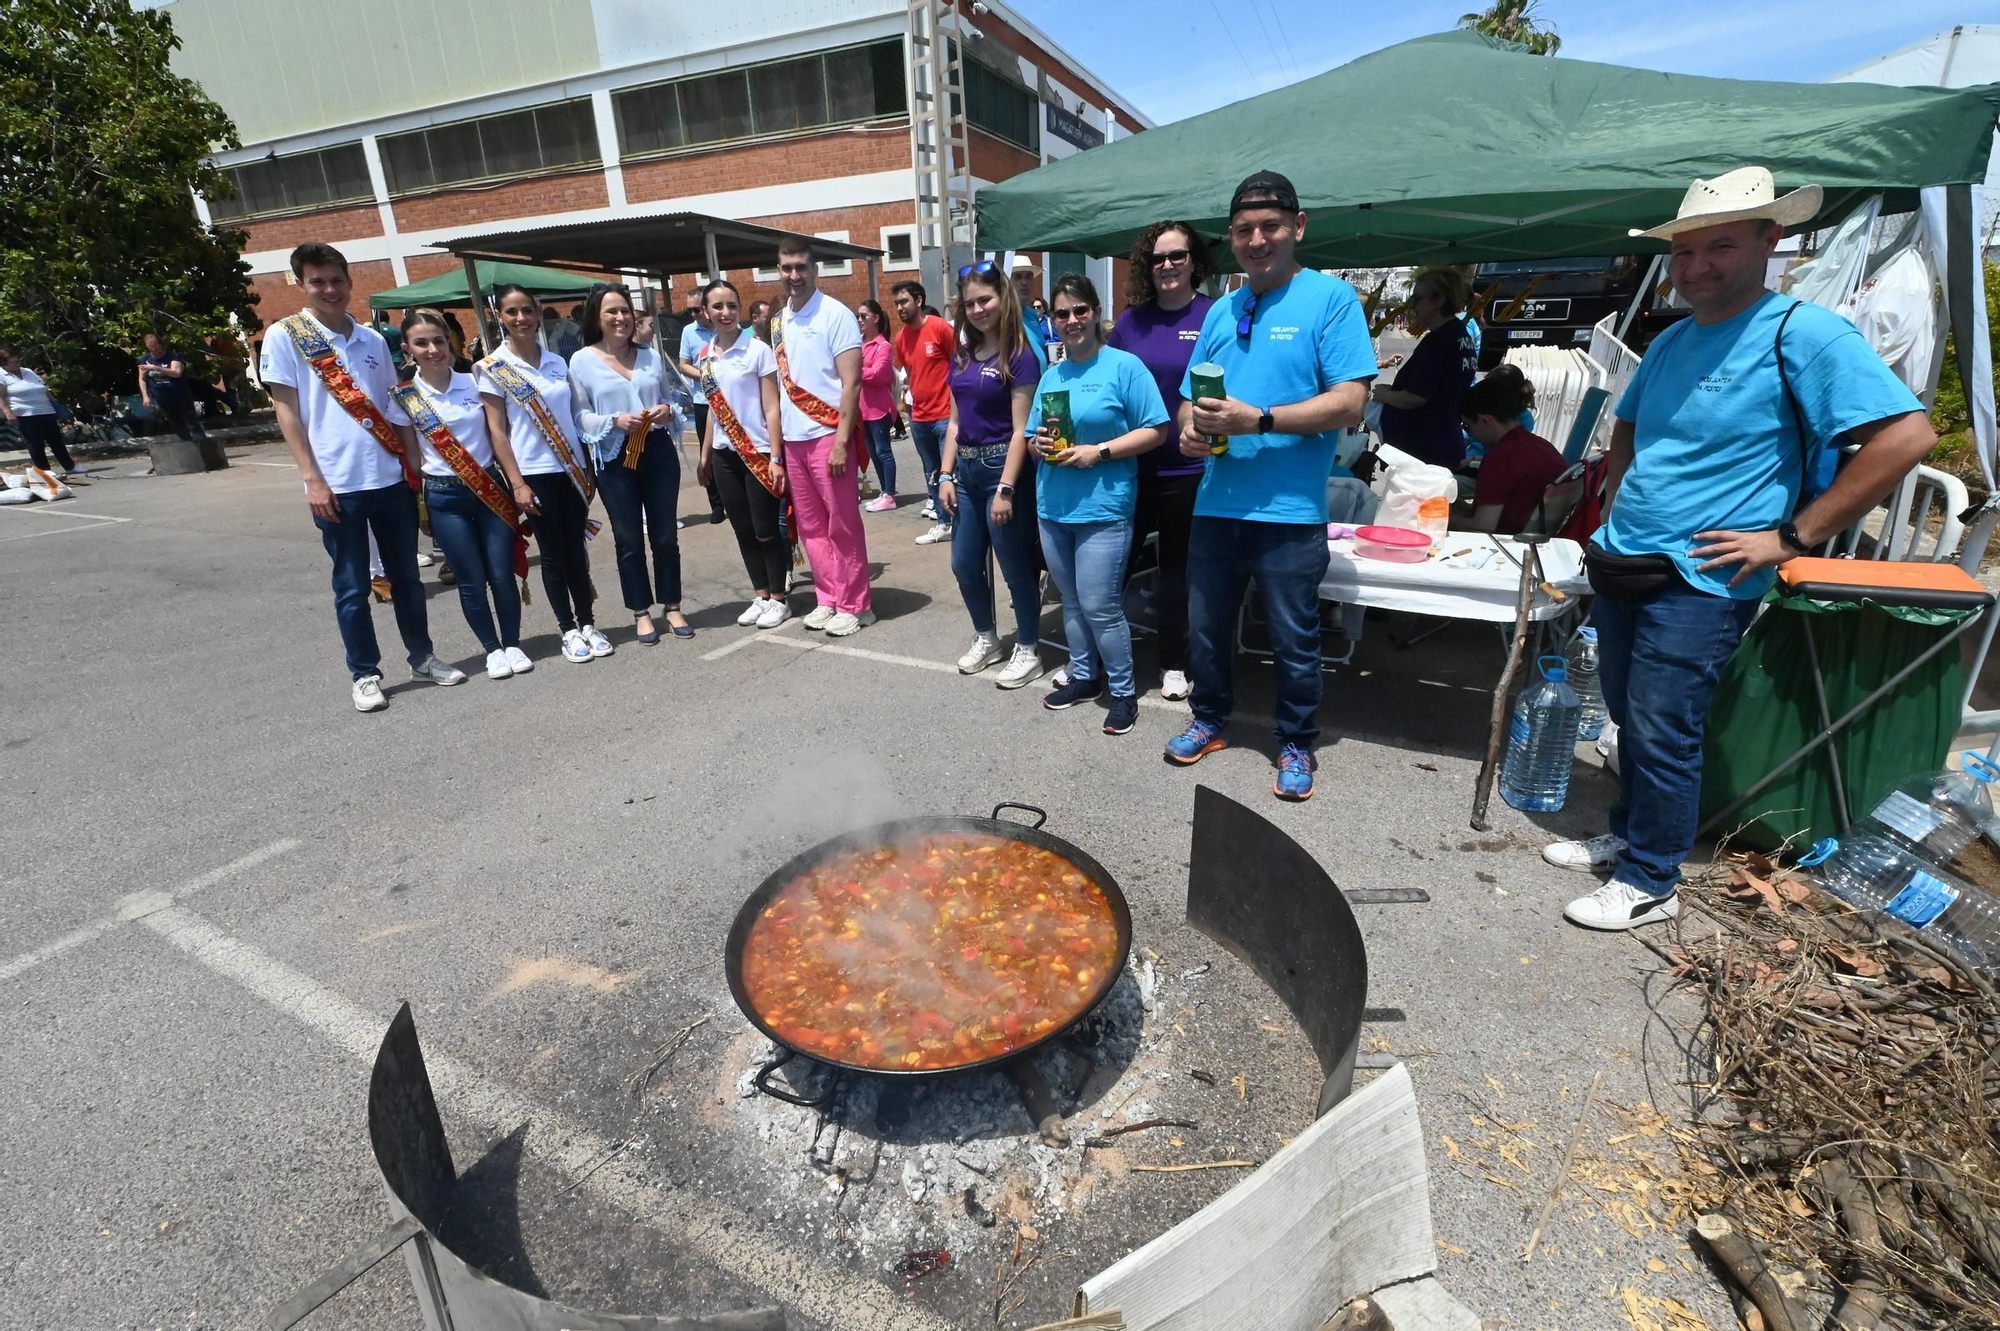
[770,240,874,638]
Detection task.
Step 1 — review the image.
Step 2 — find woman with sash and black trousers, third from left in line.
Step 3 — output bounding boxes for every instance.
[474,282,612,664]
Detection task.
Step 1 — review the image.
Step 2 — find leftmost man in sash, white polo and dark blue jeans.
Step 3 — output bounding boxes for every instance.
[258,244,466,711]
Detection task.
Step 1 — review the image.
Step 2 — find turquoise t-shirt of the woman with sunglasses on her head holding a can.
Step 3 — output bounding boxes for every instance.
[1028,346,1166,522]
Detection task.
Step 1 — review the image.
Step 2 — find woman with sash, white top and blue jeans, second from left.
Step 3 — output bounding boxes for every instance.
[396,310,534,679]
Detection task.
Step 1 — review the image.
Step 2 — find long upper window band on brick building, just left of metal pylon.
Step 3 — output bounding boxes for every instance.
[612,38,908,158]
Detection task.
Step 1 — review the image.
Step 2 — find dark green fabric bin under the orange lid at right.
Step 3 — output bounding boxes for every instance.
[1702,592,1974,849]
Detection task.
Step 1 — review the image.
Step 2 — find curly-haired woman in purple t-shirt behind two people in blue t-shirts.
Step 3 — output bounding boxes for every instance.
[1106,222,1216,699]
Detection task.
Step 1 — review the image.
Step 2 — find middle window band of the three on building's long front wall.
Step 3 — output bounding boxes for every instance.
[380,98,602,194]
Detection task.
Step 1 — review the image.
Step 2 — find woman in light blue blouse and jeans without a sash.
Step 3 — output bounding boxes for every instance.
[570,286,694,644]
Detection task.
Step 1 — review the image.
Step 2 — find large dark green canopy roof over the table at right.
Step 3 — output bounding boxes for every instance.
[978,32,2000,268]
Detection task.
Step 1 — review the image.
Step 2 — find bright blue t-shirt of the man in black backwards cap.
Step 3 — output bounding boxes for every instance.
[1172,268,1376,524]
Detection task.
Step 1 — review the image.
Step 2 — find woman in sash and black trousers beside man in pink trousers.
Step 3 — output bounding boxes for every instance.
[694,282,792,628]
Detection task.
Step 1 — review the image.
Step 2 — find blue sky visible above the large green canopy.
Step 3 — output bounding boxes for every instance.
[1008,0,2000,124]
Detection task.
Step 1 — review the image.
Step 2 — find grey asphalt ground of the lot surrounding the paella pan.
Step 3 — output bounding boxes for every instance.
[0,446,1730,1331]
